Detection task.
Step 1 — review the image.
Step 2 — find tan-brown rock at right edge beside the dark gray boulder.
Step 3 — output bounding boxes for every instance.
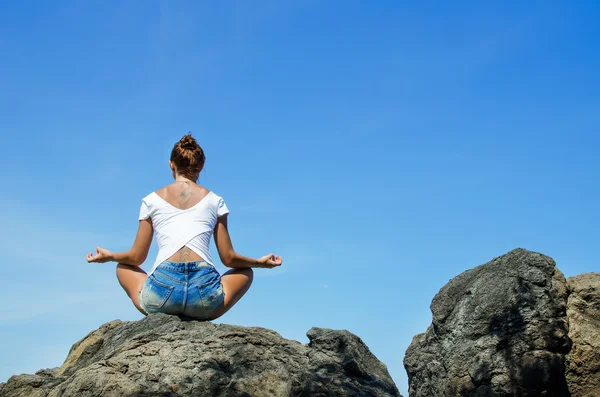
[566,273,600,397]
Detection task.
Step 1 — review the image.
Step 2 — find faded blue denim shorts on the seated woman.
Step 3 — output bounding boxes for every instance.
[140,261,225,320]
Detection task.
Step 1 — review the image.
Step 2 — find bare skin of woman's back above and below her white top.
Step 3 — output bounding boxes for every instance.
[156,181,210,262]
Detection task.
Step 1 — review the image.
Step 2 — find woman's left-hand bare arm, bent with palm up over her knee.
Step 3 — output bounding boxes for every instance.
[86,218,154,266]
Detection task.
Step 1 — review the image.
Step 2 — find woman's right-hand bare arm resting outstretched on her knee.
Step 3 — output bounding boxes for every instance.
[215,215,282,269]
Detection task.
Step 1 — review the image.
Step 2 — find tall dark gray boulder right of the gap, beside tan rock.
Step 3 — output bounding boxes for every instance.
[404,249,570,397]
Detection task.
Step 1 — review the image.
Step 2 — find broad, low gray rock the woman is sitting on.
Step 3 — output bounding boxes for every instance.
[0,314,400,397]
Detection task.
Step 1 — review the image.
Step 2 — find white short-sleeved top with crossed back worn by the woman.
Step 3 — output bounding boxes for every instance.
[139,192,229,275]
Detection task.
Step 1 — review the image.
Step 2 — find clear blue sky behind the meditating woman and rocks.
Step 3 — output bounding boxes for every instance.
[0,1,600,394]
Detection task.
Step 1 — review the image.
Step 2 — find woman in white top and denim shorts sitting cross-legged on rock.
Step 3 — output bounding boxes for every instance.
[86,134,282,320]
